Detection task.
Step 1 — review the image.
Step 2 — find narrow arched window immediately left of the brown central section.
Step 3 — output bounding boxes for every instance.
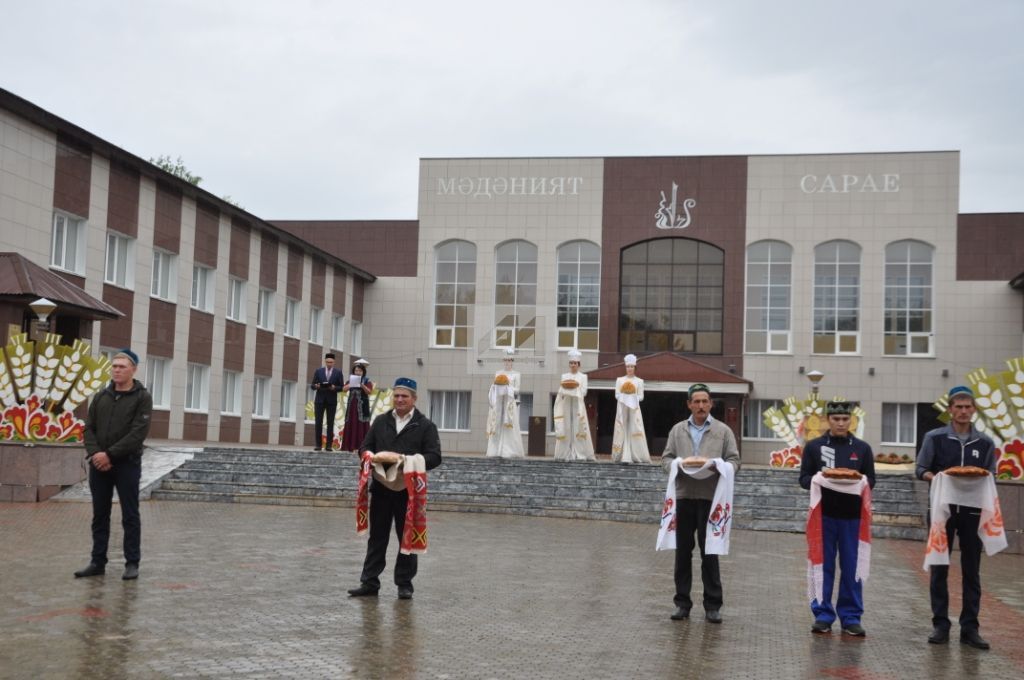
[558,241,601,349]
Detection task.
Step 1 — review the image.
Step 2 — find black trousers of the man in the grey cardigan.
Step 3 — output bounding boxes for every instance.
[673,499,722,611]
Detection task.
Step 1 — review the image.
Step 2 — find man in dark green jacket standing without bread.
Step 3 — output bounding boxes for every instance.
[75,349,153,581]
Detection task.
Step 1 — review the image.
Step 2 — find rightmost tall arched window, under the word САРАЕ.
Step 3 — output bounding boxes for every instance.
[884,241,935,356]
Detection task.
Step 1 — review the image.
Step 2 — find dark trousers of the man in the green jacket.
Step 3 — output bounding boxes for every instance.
[89,459,142,566]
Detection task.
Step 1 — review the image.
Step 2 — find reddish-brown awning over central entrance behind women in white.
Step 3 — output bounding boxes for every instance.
[587,352,754,395]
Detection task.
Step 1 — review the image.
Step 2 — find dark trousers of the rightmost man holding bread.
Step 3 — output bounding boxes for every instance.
[929,506,982,631]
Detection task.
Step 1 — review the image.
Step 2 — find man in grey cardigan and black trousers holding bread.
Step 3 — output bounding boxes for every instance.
[662,383,739,624]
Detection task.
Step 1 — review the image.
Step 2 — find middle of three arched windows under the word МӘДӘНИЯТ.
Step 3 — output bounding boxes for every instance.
[495,241,537,348]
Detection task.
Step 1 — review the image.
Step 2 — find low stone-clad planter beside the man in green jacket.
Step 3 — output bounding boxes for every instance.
[0,441,87,503]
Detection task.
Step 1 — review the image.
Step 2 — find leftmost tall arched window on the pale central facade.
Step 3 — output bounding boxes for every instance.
[433,241,476,347]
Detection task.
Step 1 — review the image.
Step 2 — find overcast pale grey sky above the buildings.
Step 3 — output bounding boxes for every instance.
[0,0,1024,219]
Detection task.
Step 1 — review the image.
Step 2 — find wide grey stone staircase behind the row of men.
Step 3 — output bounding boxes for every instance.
[153,448,928,540]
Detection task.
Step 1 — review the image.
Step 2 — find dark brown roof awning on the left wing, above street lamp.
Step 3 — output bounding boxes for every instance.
[0,253,124,321]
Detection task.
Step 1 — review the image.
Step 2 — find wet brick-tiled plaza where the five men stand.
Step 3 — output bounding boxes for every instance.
[0,501,1024,680]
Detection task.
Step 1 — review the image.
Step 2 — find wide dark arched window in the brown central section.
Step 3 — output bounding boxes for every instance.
[618,239,725,354]
